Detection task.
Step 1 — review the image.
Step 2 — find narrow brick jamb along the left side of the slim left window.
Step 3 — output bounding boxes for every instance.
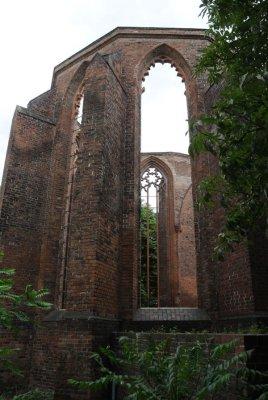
[38,62,88,306]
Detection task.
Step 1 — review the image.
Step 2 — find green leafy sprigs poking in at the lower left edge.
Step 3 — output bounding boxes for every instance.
[0,251,51,394]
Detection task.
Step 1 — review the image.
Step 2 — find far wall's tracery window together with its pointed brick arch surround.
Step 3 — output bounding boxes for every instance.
[139,153,177,307]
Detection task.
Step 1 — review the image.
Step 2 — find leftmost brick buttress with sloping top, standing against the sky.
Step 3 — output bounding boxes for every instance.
[0,107,54,288]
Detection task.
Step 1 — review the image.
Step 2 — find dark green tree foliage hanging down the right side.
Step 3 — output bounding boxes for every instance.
[189,0,268,259]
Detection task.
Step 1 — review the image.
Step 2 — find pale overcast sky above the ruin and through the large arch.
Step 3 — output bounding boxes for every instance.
[0,0,206,180]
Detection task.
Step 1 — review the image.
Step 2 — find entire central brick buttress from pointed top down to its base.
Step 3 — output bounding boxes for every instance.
[31,54,125,400]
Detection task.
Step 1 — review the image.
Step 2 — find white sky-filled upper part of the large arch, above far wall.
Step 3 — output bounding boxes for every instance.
[141,63,189,154]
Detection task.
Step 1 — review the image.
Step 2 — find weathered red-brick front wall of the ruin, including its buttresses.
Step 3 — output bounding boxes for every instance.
[0,28,268,398]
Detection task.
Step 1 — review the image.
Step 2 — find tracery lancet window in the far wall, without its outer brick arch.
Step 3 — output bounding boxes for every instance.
[140,166,166,307]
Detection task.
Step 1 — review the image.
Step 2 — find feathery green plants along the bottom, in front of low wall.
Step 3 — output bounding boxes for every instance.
[69,337,268,400]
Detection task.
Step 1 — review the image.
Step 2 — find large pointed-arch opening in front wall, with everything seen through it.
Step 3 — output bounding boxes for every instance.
[139,61,197,308]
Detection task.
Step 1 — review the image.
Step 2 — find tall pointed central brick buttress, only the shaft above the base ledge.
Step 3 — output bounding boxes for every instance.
[64,54,125,316]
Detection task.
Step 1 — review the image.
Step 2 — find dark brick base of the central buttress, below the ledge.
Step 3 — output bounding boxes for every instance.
[30,313,118,400]
